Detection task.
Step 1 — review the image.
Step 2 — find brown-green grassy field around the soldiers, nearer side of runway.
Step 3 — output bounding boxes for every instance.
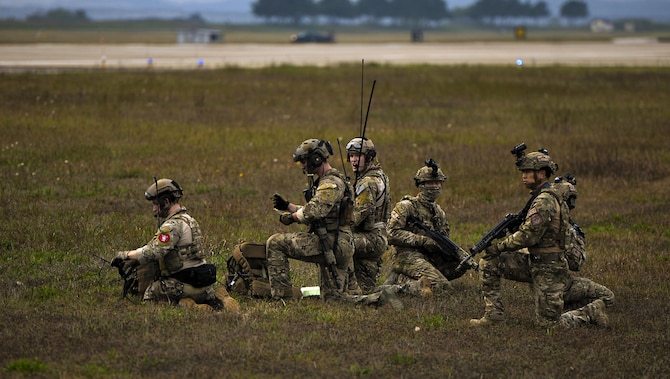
[0,65,670,378]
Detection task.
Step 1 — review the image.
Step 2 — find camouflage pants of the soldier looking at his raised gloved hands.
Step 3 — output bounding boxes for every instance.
[266,231,354,299]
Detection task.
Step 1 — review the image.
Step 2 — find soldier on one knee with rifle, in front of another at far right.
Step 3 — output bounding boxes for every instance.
[470,145,607,328]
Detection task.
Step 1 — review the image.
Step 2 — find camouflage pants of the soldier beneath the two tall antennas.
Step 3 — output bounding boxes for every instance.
[349,229,388,293]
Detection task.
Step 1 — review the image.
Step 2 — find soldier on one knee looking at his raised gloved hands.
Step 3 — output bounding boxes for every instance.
[266,139,354,300]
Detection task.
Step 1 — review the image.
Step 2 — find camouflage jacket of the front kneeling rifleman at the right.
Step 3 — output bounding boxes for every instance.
[496,187,570,253]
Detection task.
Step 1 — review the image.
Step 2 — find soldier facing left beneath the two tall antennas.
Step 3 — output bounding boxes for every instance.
[347,137,391,293]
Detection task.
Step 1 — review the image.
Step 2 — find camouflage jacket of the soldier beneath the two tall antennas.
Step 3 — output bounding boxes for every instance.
[352,165,391,232]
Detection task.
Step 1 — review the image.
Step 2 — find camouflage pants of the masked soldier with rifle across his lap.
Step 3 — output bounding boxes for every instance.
[384,249,458,292]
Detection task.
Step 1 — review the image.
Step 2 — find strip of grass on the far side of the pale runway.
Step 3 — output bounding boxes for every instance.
[0,20,670,44]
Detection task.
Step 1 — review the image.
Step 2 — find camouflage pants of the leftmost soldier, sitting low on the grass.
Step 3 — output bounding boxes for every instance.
[142,277,214,304]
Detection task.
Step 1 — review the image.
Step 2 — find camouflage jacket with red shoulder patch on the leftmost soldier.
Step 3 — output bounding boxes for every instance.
[138,207,204,276]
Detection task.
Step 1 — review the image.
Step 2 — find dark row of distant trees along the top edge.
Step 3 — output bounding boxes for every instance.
[251,0,588,25]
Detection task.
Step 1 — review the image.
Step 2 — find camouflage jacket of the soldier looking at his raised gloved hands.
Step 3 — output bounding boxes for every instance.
[296,168,353,232]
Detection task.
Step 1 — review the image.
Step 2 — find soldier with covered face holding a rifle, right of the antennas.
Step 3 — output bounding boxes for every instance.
[384,159,474,294]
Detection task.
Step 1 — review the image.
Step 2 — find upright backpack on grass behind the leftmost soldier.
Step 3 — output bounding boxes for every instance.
[226,242,272,298]
